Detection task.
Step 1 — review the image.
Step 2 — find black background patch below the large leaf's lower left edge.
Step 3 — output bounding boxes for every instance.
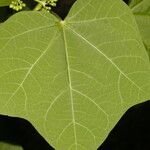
[0,115,54,150]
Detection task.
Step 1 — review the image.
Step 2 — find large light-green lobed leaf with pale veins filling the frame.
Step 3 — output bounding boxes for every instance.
[0,0,150,150]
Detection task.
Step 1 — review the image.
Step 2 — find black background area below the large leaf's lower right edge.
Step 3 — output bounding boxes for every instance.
[98,100,150,150]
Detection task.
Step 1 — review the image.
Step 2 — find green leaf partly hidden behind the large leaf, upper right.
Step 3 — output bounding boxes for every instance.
[130,0,150,57]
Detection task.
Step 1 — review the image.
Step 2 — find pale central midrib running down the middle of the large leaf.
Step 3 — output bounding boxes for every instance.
[62,27,77,149]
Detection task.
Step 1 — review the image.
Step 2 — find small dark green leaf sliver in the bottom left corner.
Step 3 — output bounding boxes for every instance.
[0,142,23,150]
